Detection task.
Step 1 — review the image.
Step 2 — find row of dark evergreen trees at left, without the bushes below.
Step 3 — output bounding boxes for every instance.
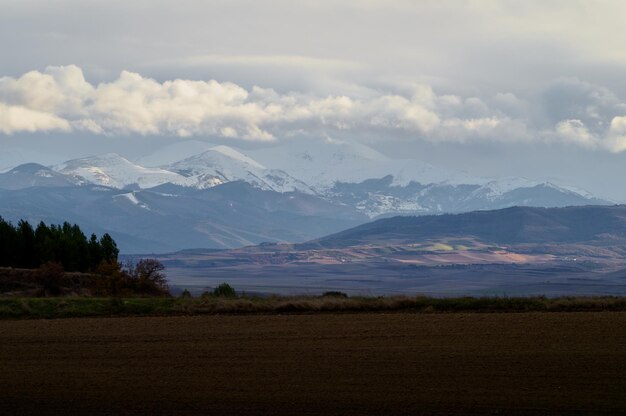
[0,217,119,272]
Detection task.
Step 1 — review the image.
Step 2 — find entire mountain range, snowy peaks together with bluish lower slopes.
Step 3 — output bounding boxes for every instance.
[0,140,609,253]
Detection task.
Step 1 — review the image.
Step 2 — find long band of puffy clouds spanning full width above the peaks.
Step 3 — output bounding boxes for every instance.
[0,65,626,152]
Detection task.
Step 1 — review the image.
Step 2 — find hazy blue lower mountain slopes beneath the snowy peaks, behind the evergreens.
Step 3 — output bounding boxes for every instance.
[0,182,366,253]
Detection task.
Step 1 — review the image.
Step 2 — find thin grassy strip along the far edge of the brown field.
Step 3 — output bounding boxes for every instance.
[0,294,626,319]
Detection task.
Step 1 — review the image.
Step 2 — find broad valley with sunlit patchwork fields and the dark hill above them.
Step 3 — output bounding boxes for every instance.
[150,206,626,296]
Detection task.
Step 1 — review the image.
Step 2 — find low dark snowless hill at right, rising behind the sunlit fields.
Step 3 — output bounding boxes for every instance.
[311,205,626,247]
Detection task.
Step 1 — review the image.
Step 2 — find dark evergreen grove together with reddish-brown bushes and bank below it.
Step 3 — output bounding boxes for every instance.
[0,218,169,297]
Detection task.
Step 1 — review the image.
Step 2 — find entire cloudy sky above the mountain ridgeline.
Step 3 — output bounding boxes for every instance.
[0,0,626,202]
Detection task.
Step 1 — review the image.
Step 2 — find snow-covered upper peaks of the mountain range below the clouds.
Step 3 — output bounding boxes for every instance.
[3,139,606,214]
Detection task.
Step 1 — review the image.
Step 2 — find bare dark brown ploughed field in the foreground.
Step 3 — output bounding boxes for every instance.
[0,312,626,415]
